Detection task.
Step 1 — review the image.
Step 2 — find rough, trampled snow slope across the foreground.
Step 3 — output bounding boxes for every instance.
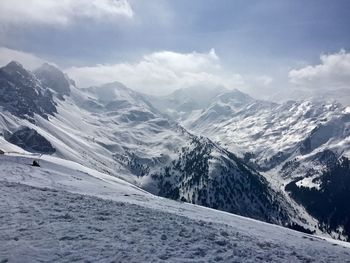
[0,156,350,262]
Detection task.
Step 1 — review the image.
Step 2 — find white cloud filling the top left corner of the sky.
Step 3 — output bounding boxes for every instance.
[0,0,134,25]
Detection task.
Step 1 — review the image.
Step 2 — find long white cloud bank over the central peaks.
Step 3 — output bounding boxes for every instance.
[66,49,246,94]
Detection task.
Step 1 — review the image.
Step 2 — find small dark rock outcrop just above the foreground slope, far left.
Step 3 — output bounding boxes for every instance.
[6,127,56,154]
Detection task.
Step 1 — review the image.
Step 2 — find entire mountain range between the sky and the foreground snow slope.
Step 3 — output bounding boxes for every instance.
[0,62,350,243]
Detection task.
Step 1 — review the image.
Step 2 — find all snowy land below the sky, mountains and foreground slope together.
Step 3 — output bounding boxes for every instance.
[0,62,350,262]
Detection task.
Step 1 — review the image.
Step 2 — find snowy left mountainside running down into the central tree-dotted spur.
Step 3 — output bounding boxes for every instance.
[0,62,306,231]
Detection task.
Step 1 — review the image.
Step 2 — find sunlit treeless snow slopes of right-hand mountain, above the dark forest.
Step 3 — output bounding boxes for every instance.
[183,90,350,170]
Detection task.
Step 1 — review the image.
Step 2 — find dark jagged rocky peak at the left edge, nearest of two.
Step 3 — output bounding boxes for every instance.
[0,62,57,120]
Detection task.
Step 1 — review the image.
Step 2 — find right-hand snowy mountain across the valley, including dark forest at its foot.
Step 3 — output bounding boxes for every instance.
[158,86,350,241]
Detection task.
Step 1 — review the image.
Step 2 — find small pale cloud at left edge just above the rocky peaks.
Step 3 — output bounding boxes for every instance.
[0,47,45,70]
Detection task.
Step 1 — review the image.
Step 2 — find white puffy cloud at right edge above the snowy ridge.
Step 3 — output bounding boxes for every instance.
[289,50,350,90]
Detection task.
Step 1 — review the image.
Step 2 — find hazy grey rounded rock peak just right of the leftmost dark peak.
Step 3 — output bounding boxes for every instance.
[34,63,70,98]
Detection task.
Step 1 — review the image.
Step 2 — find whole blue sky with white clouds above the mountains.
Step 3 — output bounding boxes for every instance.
[0,0,350,101]
